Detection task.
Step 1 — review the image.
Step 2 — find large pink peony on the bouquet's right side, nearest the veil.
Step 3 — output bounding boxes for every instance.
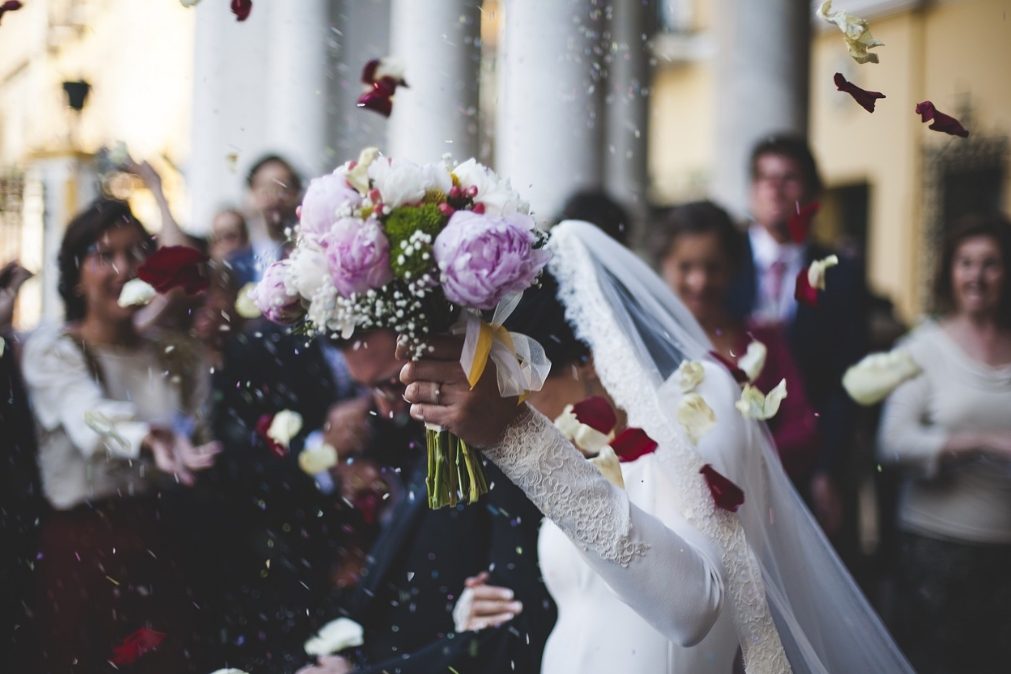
[434,211,550,309]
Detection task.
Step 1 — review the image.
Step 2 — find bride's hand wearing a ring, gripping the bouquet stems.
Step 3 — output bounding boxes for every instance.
[396,336,523,447]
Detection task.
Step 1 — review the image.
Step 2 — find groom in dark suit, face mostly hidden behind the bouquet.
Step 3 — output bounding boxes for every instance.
[300,330,555,674]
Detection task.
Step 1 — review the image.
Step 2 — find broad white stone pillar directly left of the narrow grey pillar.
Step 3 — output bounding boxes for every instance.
[495,0,604,222]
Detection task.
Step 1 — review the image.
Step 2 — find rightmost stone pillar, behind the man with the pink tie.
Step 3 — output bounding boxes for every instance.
[712,0,811,216]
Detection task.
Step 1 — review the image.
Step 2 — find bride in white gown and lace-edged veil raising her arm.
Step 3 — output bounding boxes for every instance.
[401,221,912,674]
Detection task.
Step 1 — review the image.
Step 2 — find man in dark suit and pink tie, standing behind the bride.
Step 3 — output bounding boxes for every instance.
[733,135,868,549]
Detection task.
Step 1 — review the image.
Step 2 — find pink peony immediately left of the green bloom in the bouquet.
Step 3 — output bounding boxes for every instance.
[320,217,393,297]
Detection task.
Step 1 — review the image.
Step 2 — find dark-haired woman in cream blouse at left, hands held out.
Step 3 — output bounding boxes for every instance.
[24,199,218,673]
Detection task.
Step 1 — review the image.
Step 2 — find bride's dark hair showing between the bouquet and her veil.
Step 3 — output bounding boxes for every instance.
[506,271,590,375]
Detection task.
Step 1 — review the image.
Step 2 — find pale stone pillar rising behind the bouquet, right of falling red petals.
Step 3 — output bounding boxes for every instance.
[388,0,481,163]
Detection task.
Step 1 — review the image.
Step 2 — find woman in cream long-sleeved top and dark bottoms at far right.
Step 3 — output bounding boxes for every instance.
[880,215,1011,673]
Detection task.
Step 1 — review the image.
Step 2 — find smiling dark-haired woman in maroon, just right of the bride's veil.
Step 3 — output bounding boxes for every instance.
[652,201,818,487]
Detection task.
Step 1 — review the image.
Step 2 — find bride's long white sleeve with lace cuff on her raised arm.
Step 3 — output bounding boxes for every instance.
[484,408,723,646]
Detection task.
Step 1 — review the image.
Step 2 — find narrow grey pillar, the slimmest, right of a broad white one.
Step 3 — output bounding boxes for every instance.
[604,0,651,219]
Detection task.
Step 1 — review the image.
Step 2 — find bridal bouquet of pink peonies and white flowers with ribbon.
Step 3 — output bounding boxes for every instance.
[254,148,551,508]
